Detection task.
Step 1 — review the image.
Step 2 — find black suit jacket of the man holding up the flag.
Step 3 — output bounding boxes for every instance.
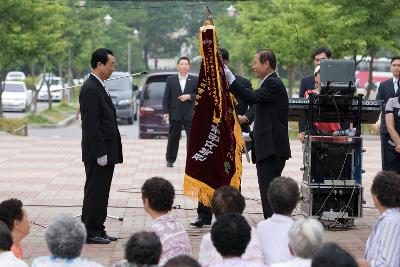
[230,73,291,162]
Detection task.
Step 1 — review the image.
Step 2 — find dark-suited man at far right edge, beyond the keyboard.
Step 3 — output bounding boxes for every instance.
[376,56,400,171]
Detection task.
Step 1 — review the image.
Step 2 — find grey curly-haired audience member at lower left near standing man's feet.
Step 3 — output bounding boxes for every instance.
[32,215,102,267]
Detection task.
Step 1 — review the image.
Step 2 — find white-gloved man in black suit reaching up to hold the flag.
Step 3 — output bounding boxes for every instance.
[225,49,291,218]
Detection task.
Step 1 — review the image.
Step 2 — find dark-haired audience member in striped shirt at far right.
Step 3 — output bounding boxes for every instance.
[360,171,400,267]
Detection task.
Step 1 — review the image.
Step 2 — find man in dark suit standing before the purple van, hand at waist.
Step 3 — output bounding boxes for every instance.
[163,57,197,167]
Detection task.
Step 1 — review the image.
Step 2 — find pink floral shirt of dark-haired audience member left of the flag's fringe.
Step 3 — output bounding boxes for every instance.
[145,214,192,265]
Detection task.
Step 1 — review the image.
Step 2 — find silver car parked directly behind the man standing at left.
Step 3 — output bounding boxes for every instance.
[105,72,139,124]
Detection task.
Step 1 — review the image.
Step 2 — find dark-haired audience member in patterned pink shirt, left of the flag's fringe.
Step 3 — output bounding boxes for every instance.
[142,177,192,265]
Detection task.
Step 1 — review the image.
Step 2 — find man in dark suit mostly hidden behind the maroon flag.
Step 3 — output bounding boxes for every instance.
[190,48,255,228]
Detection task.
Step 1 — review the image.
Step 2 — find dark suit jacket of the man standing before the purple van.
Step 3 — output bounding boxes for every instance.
[163,74,197,121]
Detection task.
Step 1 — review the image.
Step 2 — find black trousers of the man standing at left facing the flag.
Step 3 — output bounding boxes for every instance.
[81,163,115,237]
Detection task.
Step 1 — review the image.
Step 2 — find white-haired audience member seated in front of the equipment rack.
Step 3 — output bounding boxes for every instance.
[271,218,324,267]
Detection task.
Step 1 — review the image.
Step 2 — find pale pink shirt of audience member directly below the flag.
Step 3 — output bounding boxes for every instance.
[199,228,264,266]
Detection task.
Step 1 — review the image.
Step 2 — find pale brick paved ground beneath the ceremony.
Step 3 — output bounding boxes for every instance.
[0,136,381,266]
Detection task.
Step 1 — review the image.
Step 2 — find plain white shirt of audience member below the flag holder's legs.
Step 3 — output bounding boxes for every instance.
[257,213,294,266]
